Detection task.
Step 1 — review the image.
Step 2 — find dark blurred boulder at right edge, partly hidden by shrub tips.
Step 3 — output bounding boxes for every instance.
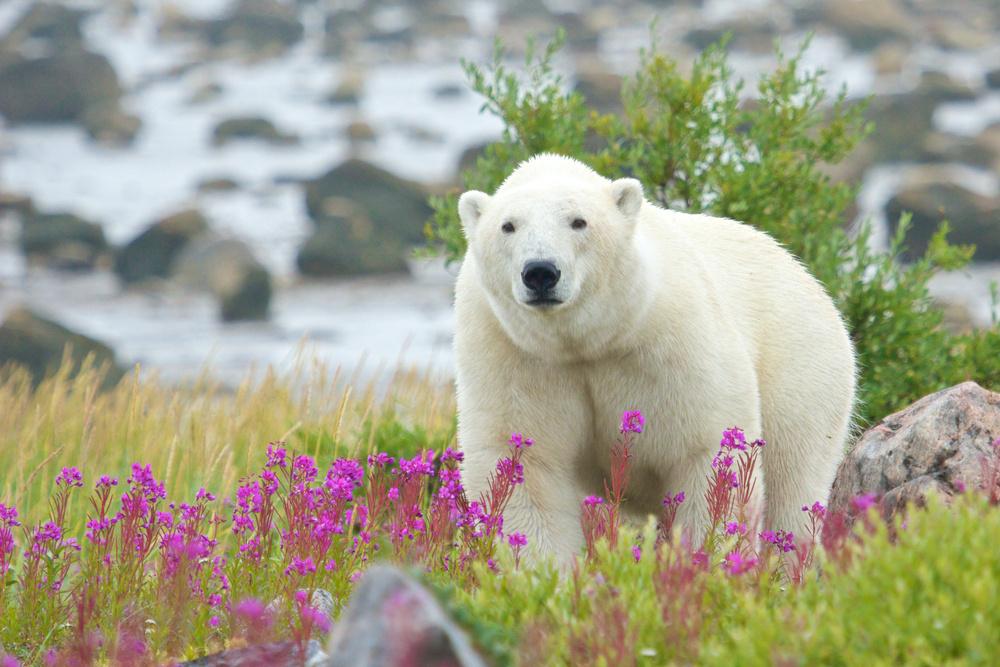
[885,180,1000,262]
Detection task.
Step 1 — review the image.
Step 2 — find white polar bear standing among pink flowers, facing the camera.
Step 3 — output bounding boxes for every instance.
[454,154,856,562]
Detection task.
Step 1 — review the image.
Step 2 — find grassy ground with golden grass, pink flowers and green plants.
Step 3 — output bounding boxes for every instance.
[0,363,1000,665]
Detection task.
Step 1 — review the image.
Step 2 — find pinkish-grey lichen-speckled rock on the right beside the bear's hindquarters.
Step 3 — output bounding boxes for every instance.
[829,382,1000,519]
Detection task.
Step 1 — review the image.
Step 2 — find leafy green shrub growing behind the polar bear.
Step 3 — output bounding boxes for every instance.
[427,30,1000,422]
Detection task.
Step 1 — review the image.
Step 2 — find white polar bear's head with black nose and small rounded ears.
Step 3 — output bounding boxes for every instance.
[458,154,645,358]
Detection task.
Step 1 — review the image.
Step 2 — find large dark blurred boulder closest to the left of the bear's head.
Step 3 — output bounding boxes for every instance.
[298,160,432,276]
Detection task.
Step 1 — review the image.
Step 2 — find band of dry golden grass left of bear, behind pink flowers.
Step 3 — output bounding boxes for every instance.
[0,354,455,526]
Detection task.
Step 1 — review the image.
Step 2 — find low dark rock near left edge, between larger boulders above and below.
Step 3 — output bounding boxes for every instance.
[21,213,109,270]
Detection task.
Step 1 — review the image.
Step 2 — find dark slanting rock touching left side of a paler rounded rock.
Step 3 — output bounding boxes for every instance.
[115,210,208,284]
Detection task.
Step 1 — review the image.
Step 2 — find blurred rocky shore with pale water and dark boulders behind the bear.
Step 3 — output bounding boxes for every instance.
[0,0,1000,383]
